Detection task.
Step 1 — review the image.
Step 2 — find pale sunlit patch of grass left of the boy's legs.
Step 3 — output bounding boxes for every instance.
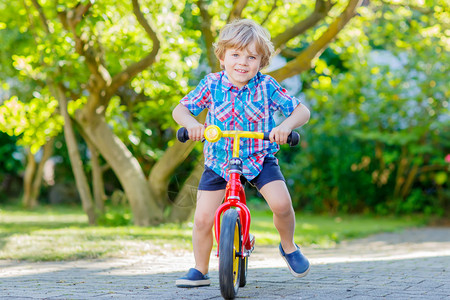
[0,228,191,261]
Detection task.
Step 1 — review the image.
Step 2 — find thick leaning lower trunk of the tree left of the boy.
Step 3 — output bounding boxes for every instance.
[76,111,163,226]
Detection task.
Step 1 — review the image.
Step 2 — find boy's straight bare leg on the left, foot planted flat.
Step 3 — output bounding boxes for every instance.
[192,190,225,274]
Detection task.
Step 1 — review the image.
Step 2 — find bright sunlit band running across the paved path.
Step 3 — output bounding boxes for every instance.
[0,239,450,278]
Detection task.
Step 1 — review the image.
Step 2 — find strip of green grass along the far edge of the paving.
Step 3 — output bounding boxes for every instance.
[0,206,425,261]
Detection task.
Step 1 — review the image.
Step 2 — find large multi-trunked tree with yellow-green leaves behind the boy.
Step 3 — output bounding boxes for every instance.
[2,0,362,225]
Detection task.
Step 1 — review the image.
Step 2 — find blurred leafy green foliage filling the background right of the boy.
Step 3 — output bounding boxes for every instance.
[284,1,450,214]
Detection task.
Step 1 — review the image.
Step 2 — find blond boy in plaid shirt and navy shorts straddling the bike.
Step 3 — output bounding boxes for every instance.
[173,20,310,287]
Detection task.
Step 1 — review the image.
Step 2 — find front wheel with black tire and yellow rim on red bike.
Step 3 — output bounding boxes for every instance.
[219,209,242,299]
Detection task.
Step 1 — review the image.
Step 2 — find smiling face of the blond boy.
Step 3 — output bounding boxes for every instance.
[220,43,261,88]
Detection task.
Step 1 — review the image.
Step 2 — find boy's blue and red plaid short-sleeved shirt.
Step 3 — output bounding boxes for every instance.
[180,71,300,180]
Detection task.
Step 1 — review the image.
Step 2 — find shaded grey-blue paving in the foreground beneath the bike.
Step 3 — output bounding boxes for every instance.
[0,256,450,300]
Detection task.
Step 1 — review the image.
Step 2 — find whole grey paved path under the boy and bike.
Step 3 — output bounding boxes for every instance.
[0,228,450,300]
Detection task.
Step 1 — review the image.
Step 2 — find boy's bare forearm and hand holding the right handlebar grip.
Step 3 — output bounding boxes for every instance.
[269,103,311,145]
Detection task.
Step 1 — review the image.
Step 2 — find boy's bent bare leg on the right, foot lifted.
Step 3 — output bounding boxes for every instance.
[259,180,297,253]
